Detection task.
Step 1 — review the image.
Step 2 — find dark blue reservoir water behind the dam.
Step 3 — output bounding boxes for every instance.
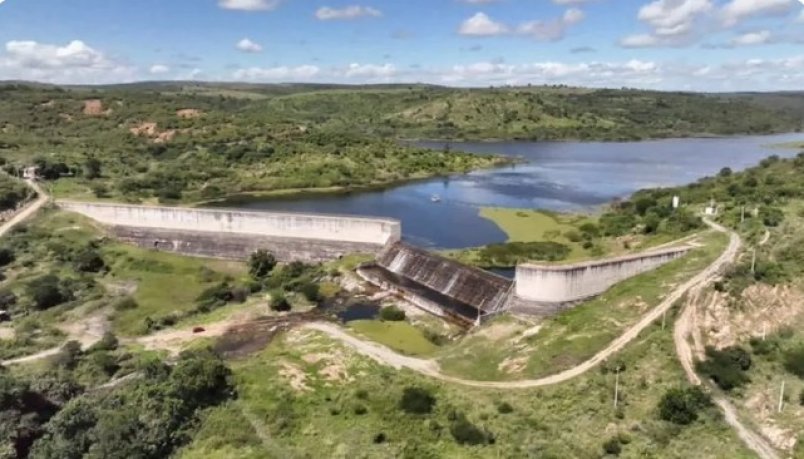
[223,134,804,252]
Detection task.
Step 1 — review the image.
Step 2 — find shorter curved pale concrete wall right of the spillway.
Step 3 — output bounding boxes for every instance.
[515,247,689,306]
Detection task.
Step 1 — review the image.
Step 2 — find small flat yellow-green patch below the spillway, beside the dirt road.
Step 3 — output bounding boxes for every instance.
[348,320,438,357]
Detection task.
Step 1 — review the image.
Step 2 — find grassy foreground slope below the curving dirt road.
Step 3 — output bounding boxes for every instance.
[179,308,753,458]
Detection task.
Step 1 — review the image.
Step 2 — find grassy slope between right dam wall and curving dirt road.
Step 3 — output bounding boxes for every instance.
[439,233,727,380]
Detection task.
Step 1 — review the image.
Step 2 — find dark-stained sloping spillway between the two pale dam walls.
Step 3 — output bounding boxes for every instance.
[361,242,513,323]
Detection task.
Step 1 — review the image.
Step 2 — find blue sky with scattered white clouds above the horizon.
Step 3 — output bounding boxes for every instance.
[0,0,804,91]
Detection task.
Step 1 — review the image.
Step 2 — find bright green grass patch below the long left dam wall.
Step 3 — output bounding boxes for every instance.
[104,244,245,336]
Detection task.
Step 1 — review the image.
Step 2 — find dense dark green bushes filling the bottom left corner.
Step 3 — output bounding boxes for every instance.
[0,348,234,459]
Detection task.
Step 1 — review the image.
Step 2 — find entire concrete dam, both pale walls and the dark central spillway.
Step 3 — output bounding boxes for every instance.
[56,201,690,325]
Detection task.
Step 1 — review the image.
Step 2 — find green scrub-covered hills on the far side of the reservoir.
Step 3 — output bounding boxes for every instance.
[0,84,802,202]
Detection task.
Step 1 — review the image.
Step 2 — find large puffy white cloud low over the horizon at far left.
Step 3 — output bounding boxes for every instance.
[0,40,136,83]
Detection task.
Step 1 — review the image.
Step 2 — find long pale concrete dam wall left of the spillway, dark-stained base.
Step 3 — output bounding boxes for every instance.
[57,201,402,261]
